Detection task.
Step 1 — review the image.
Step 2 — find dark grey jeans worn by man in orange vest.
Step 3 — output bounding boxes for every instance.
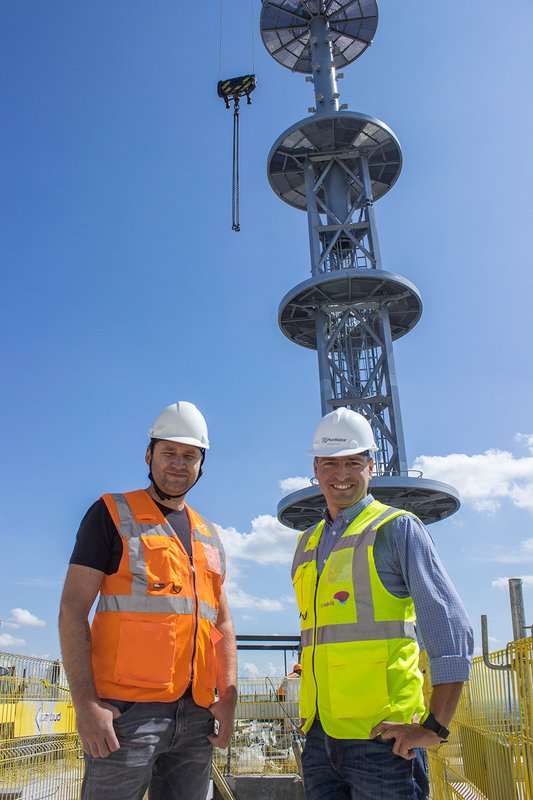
[81,695,214,800]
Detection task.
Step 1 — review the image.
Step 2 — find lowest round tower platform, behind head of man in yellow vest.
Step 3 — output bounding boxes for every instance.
[277,475,461,531]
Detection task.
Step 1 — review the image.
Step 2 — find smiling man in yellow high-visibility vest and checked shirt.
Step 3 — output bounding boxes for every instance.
[292,408,473,800]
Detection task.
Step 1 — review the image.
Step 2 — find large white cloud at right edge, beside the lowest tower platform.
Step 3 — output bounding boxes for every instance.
[413,433,533,513]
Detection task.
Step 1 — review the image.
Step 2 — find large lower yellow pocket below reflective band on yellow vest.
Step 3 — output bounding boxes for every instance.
[326,641,390,721]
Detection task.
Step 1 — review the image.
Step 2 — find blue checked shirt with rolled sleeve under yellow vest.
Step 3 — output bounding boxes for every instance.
[317,495,474,686]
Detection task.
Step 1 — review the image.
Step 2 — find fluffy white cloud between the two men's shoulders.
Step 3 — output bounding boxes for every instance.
[220,514,297,564]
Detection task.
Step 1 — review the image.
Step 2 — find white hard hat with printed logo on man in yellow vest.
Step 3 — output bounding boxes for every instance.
[307,408,379,458]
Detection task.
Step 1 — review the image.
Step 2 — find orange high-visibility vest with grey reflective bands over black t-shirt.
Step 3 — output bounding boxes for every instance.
[91,490,225,707]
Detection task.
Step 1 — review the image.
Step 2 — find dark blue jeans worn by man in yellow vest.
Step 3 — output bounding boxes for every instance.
[302,720,426,800]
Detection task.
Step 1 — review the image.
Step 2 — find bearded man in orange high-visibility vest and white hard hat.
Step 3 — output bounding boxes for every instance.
[59,401,237,800]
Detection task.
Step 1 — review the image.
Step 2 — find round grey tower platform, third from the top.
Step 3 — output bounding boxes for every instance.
[278,269,422,350]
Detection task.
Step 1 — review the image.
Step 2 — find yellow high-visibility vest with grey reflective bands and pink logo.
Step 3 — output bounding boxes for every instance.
[292,500,424,739]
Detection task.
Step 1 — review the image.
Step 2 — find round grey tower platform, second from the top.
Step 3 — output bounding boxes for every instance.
[267,111,402,211]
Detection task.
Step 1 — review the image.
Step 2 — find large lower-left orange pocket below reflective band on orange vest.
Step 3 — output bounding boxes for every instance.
[115,619,176,688]
